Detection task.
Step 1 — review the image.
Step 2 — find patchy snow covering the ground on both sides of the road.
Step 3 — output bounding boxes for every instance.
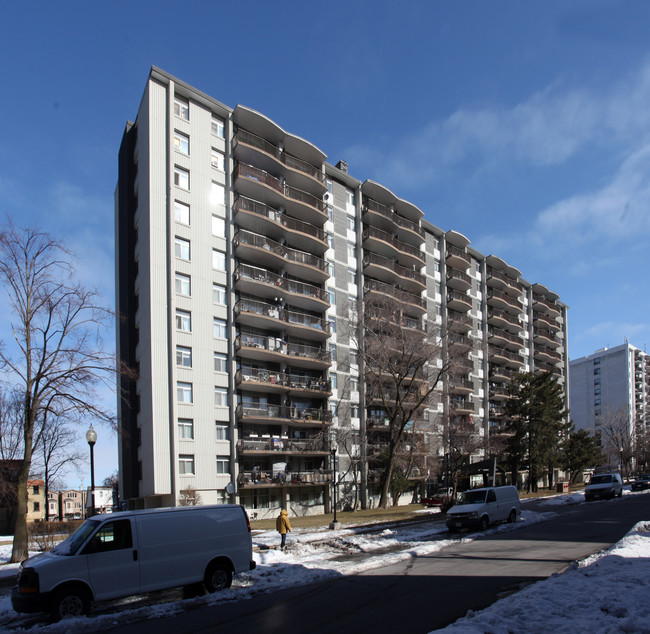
[0,493,650,634]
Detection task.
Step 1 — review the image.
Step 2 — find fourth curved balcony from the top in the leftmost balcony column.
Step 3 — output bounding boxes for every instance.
[233,229,329,284]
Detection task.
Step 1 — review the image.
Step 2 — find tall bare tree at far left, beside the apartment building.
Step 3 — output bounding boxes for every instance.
[0,220,115,562]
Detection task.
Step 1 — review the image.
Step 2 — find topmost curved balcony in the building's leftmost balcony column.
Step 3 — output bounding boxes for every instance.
[233,128,327,196]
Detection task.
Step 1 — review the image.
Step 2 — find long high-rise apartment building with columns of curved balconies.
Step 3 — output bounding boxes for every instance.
[116,68,568,516]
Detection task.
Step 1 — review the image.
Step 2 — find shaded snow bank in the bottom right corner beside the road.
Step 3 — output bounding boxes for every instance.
[437,522,650,634]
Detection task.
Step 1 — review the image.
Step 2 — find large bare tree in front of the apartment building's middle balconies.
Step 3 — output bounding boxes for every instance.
[351,296,449,508]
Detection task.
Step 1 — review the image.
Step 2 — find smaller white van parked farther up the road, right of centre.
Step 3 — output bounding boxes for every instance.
[447,486,521,531]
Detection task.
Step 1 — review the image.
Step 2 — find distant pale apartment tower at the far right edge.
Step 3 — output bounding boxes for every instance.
[569,343,650,432]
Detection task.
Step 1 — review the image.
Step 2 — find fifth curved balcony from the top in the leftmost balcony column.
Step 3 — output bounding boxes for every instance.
[234,264,330,311]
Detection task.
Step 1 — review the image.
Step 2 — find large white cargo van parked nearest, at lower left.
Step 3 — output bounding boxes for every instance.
[11,504,255,619]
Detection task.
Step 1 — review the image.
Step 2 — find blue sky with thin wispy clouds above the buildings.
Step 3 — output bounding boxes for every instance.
[0,0,650,485]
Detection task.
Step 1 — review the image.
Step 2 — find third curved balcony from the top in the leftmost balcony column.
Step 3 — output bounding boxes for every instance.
[233,196,328,255]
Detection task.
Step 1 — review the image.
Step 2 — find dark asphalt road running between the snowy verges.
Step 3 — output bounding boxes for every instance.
[107,494,650,634]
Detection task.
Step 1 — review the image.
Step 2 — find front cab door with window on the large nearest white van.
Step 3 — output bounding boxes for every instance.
[82,518,140,600]
